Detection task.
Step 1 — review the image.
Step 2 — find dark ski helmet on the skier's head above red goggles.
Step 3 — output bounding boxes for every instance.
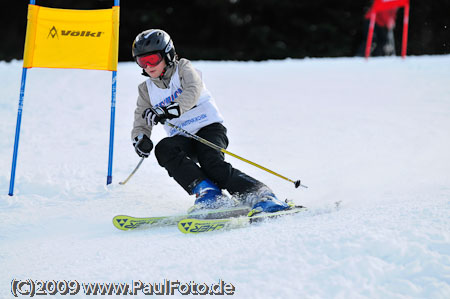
[131,29,176,65]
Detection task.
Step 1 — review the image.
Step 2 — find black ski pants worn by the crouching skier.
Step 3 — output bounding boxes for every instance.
[155,123,264,195]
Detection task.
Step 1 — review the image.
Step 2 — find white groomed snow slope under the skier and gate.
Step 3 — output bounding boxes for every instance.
[0,55,450,298]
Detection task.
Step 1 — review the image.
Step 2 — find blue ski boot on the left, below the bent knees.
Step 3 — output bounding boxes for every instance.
[188,179,231,213]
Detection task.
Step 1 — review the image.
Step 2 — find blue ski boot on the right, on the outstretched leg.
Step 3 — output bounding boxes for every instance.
[247,187,293,217]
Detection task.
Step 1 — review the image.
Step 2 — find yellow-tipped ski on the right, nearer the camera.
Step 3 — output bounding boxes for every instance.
[178,206,307,234]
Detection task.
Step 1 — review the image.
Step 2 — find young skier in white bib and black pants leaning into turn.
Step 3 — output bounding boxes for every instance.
[131,29,290,214]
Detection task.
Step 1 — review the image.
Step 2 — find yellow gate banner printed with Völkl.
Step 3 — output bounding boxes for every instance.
[23,4,119,71]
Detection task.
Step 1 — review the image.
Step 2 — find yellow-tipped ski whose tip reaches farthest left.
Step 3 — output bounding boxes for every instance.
[113,207,250,231]
